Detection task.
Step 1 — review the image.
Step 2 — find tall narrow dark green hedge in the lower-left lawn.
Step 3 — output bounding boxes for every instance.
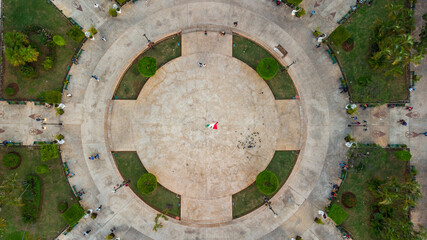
[21,175,41,223]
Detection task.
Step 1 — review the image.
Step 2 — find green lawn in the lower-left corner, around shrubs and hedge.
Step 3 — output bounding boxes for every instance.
[0,147,75,240]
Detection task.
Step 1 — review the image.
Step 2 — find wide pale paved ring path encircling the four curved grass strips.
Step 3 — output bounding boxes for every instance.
[53,1,345,239]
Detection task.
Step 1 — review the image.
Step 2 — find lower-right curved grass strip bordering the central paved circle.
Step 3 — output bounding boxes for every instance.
[233,151,299,218]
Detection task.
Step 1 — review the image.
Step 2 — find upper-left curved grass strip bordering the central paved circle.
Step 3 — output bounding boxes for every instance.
[113,34,181,99]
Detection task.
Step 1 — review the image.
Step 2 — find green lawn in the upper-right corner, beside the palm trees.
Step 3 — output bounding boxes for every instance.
[332,0,408,103]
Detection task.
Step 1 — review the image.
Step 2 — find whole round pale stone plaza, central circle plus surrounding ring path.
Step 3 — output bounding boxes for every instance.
[2,0,402,239]
